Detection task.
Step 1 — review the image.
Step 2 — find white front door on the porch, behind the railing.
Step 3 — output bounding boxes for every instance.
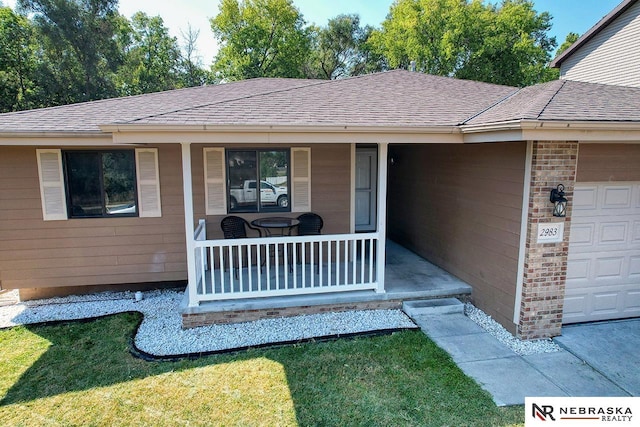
[355,148,378,232]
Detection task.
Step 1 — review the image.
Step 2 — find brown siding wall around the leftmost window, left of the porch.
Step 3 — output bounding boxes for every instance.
[0,145,186,298]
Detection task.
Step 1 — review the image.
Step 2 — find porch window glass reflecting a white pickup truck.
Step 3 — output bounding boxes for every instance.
[226,149,291,213]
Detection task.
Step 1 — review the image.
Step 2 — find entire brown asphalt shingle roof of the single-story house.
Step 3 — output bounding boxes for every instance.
[0,70,640,134]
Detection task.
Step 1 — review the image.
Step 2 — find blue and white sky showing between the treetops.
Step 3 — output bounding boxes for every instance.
[5,0,622,66]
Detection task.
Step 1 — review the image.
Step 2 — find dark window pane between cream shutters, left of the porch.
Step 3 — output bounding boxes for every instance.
[62,150,138,218]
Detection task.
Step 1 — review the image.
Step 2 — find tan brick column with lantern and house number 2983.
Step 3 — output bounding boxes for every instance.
[517,141,578,339]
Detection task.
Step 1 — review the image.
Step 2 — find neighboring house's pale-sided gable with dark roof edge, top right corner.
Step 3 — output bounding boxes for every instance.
[560,2,640,87]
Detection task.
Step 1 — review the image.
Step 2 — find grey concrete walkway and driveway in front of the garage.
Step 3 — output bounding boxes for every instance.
[405,300,640,406]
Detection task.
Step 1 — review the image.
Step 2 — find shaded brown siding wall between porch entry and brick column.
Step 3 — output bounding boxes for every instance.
[388,143,526,332]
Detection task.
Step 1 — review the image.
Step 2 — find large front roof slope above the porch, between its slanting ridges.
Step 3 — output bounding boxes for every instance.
[130,70,517,127]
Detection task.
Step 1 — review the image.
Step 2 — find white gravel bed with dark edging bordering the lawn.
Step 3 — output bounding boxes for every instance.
[0,290,416,356]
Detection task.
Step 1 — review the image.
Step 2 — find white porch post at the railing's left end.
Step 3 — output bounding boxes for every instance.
[180,142,198,307]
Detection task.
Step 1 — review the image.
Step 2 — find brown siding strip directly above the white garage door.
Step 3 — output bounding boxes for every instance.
[576,144,640,182]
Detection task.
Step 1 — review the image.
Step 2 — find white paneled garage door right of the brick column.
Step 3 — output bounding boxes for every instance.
[563,182,640,323]
